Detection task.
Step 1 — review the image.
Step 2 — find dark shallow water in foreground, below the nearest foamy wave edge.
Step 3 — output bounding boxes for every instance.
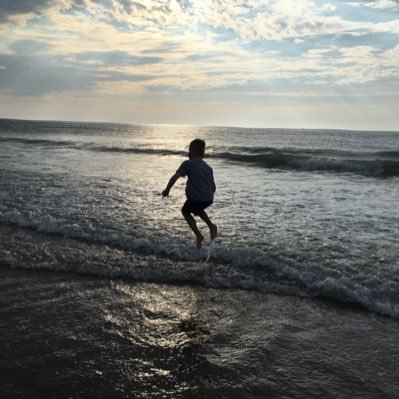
[0,267,399,399]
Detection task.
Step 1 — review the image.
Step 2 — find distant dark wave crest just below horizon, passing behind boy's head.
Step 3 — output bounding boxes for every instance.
[0,137,399,177]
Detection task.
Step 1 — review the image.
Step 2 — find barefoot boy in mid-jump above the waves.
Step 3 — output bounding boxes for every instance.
[162,139,217,248]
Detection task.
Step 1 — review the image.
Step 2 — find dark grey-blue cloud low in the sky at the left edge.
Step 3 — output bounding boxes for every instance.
[0,40,161,96]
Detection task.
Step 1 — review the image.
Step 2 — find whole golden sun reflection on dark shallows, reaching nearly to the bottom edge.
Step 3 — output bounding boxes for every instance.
[98,281,209,397]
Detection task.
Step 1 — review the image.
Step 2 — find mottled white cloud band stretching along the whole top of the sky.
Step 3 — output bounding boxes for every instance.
[0,0,399,40]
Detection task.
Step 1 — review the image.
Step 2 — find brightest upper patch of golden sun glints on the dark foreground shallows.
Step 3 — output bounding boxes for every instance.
[104,282,206,349]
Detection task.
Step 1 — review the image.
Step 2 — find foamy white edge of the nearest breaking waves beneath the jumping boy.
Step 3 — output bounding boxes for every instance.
[0,207,399,318]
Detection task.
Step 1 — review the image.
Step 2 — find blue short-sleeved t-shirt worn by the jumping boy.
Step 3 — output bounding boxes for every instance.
[176,159,213,202]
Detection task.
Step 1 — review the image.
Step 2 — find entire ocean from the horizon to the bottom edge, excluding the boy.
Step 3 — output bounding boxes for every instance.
[0,119,399,399]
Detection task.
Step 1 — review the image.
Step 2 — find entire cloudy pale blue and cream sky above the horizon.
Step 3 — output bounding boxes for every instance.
[0,0,399,131]
